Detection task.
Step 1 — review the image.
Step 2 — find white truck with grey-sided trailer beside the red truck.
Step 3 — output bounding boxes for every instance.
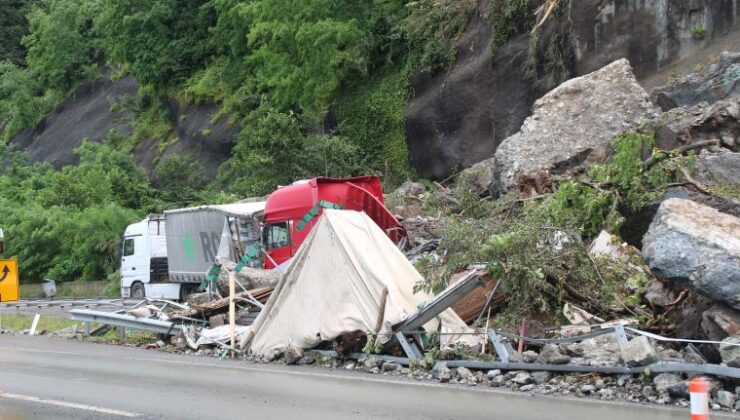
[121,202,265,300]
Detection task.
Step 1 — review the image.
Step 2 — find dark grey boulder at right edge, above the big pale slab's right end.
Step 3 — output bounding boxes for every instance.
[652,52,740,110]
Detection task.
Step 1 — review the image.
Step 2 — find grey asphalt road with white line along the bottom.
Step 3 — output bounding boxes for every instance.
[0,335,729,420]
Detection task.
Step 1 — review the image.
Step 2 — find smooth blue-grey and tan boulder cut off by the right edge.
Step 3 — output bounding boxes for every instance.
[642,199,740,309]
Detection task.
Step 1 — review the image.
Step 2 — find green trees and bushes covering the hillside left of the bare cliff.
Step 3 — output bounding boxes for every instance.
[0,0,477,281]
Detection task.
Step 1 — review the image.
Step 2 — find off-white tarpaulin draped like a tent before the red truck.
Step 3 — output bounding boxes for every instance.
[245,210,472,358]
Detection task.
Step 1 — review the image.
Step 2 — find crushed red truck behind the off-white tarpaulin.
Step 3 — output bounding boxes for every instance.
[262,176,406,268]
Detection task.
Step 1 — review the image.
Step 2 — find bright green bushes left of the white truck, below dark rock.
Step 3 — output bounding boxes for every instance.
[0,143,153,282]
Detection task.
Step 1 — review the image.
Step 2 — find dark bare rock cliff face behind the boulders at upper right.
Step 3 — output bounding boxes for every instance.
[406,0,740,179]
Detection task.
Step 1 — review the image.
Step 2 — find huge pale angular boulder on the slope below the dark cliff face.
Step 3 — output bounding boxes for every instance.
[491,59,658,195]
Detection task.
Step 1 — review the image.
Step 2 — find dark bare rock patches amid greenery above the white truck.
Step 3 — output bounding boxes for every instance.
[13,76,239,178]
